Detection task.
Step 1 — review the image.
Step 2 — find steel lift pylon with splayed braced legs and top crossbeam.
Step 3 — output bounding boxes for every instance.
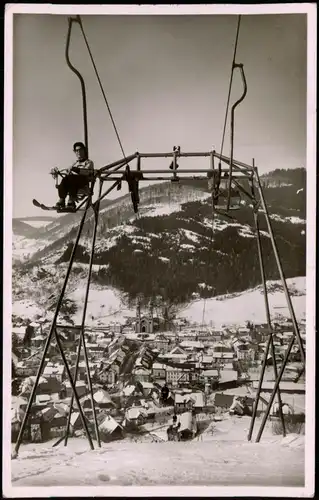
[15,148,305,455]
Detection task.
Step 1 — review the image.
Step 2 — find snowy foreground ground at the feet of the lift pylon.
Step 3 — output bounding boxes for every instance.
[11,417,305,496]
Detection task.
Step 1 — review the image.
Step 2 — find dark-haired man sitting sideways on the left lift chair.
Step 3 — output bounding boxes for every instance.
[55,142,94,210]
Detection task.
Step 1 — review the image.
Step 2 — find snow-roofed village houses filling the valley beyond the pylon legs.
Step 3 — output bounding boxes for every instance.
[12,292,305,484]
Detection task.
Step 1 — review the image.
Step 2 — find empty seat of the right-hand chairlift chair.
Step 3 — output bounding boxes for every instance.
[207,172,242,211]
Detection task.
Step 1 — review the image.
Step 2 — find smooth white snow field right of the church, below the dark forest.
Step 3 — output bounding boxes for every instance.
[179,276,306,327]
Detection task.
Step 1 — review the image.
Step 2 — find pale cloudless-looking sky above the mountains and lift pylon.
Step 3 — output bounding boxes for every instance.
[13,14,307,217]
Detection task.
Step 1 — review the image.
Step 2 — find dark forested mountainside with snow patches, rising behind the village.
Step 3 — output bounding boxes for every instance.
[13,169,306,312]
